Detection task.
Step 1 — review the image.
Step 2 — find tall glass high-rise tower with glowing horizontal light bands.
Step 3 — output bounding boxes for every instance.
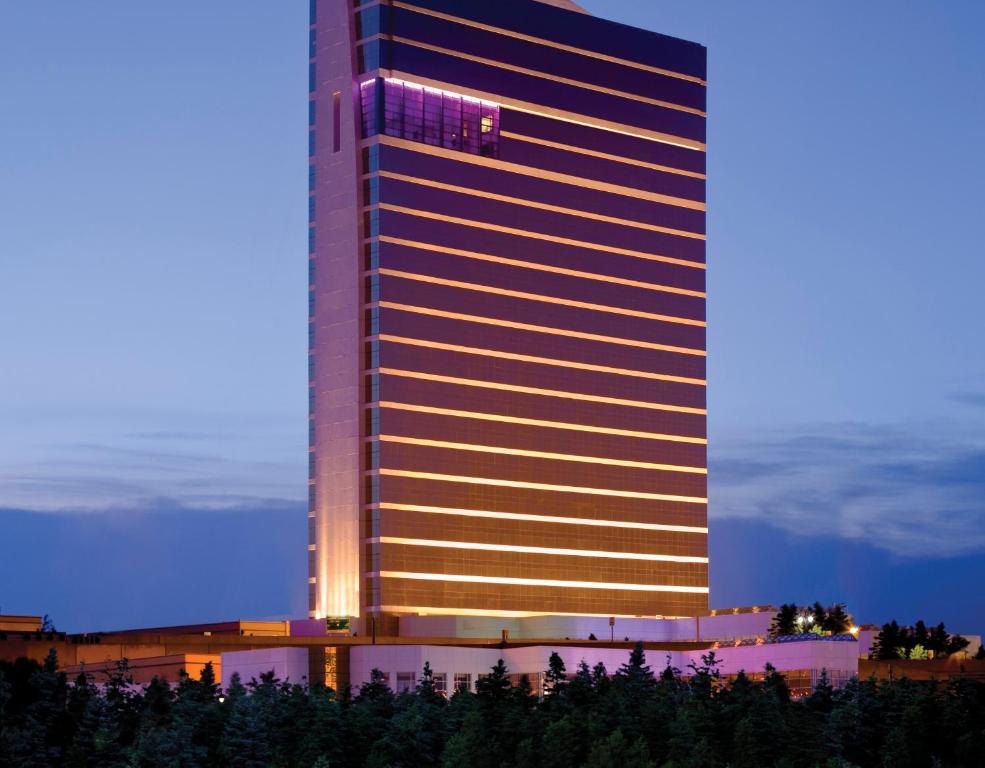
[309,0,708,618]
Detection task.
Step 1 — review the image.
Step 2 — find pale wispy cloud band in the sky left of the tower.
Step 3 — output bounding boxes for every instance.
[0,408,307,513]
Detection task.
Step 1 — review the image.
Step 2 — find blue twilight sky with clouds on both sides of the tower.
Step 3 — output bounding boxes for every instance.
[0,0,985,633]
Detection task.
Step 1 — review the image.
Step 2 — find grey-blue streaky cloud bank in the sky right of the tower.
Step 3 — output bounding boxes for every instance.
[711,424,985,556]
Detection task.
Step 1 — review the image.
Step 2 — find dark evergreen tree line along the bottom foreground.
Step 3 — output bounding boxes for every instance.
[0,646,985,768]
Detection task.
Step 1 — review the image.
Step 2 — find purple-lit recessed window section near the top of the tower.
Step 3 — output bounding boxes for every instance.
[362,78,499,157]
